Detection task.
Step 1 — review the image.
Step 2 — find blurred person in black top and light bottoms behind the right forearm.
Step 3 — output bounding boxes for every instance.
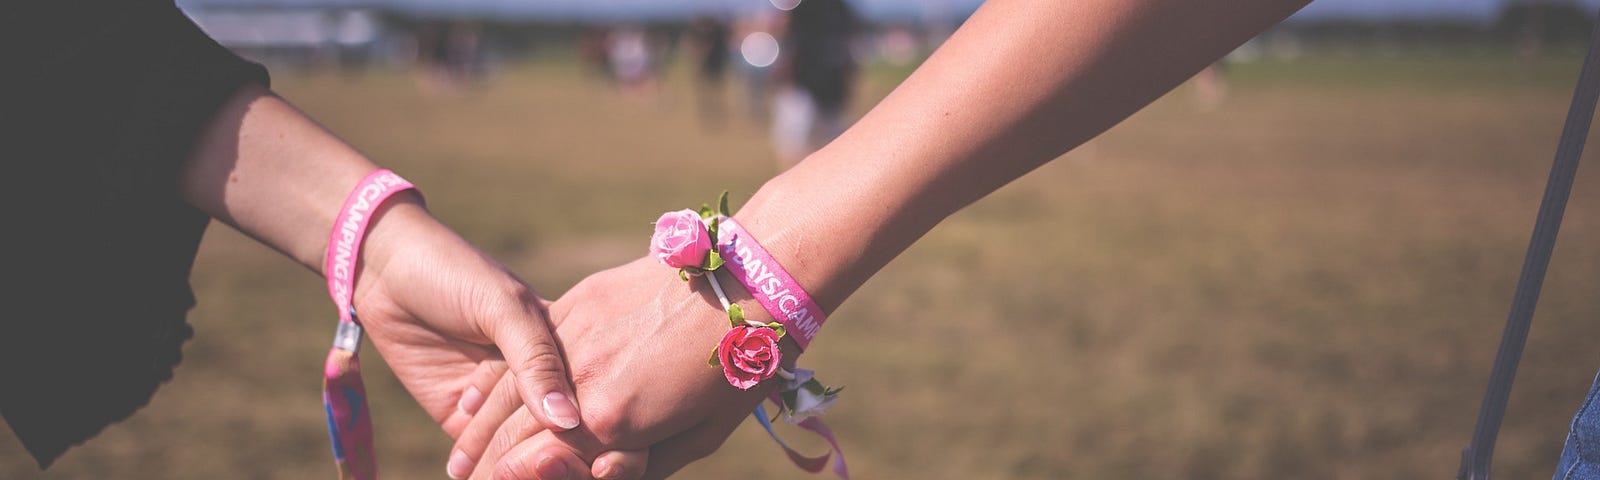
[771,0,856,168]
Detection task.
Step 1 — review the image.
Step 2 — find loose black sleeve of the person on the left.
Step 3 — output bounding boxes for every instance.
[0,0,267,467]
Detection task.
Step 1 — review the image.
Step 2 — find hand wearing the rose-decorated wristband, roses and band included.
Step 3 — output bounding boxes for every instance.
[453,200,845,478]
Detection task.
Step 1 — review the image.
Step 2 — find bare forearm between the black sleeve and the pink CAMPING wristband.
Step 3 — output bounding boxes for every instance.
[179,85,429,272]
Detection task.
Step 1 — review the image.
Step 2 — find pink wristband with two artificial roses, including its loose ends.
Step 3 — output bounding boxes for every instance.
[650,192,850,478]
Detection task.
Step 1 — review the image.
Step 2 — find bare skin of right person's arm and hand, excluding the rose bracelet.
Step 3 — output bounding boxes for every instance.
[451,0,1307,480]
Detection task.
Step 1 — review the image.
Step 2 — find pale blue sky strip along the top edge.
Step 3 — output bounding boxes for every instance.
[178,0,1600,22]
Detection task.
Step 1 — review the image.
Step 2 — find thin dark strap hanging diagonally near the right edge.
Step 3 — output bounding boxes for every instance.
[1456,11,1600,480]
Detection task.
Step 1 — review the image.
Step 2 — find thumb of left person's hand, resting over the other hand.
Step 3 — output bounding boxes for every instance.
[483,284,579,430]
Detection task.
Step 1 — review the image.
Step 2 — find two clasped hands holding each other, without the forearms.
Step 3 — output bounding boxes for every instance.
[357,216,795,480]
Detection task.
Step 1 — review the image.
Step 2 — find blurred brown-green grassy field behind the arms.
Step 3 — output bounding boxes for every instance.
[0,50,1600,478]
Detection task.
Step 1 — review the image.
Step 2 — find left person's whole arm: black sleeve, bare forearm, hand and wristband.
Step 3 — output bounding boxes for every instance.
[9,2,642,478]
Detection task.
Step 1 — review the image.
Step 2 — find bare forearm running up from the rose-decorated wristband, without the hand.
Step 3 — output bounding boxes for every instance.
[739,0,1304,310]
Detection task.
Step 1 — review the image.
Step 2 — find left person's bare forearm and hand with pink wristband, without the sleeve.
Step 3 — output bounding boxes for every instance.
[179,85,643,478]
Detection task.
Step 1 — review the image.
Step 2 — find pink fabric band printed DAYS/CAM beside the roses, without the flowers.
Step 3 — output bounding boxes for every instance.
[717,216,827,350]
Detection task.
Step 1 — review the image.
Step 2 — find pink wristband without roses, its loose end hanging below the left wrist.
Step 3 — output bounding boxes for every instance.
[322,170,414,480]
